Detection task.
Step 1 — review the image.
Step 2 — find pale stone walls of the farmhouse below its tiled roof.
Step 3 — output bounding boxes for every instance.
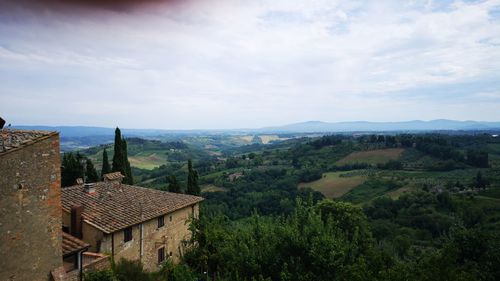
[63,200,199,271]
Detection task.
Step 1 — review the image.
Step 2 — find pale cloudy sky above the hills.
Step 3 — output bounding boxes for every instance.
[0,0,500,129]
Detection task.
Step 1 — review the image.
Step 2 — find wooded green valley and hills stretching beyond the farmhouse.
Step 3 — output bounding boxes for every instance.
[63,130,500,280]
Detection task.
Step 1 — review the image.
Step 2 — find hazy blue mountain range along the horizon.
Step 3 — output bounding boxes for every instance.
[13,119,500,138]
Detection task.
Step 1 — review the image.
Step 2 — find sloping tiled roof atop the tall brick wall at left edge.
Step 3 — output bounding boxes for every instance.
[0,129,58,155]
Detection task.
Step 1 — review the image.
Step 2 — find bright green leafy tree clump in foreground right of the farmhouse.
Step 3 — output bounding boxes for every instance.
[185,200,380,280]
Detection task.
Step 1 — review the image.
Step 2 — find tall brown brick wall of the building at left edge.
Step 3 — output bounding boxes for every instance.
[0,133,62,280]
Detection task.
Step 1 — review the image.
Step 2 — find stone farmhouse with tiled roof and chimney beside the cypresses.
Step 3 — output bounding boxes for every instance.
[62,172,203,271]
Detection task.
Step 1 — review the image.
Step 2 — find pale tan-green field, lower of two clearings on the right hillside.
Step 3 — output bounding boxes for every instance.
[299,172,366,198]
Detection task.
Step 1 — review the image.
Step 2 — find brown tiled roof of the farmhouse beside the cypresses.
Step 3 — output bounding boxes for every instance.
[61,182,203,233]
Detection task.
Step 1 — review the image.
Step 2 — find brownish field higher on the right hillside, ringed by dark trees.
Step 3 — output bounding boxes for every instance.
[336,148,404,165]
